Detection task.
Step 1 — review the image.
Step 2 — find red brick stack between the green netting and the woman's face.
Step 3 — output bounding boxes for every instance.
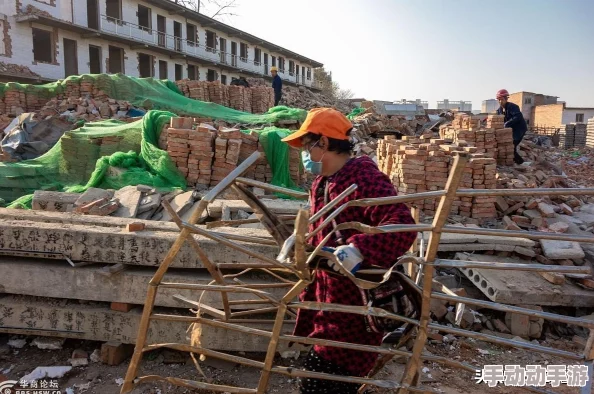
[159,118,304,189]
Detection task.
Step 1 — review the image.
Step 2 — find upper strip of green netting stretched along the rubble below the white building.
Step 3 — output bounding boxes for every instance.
[0,74,307,124]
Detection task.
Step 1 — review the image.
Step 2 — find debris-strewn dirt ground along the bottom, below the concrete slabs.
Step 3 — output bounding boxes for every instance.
[0,336,579,394]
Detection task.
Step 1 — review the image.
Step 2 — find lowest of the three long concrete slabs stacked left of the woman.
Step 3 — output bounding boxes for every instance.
[0,296,293,352]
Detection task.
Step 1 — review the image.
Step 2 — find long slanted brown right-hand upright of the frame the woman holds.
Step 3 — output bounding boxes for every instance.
[398,153,468,394]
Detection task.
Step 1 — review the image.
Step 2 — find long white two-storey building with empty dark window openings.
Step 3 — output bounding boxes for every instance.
[0,0,323,89]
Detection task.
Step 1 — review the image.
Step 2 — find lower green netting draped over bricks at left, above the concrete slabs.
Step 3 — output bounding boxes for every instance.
[0,111,186,208]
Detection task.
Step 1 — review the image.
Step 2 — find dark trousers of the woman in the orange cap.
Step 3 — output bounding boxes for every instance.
[299,349,361,394]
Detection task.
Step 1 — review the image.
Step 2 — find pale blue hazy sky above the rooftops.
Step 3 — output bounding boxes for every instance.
[224,0,594,109]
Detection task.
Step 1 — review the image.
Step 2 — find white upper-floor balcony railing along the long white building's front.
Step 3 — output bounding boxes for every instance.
[99,15,318,87]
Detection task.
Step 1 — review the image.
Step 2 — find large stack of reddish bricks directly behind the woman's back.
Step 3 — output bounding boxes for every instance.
[377,136,497,219]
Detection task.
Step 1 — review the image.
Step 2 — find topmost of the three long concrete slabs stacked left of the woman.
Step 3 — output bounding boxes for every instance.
[0,220,278,268]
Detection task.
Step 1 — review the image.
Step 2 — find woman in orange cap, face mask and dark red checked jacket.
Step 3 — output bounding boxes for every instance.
[283,108,416,394]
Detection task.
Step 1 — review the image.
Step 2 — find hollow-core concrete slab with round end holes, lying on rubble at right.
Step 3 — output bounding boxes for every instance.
[456,253,594,307]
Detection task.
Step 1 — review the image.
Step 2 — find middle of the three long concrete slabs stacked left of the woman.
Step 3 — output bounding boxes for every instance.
[0,257,289,309]
